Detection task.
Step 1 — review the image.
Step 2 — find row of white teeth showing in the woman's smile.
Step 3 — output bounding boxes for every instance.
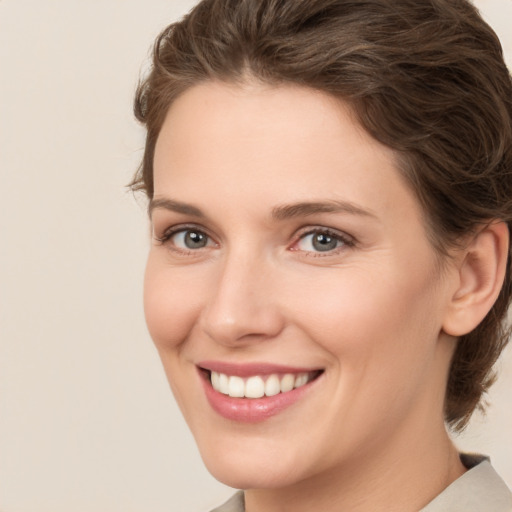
[211,371,311,398]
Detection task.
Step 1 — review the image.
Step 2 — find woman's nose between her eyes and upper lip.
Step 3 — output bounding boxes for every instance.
[200,249,285,347]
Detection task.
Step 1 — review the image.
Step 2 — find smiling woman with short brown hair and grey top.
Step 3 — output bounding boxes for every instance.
[132,0,512,512]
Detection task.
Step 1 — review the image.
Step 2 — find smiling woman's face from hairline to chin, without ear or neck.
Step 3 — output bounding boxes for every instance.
[145,83,453,488]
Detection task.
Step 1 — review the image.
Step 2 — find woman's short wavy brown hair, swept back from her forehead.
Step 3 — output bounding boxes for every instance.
[131,0,512,430]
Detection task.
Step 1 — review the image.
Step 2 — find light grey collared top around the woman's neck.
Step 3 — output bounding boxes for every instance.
[211,454,512,512]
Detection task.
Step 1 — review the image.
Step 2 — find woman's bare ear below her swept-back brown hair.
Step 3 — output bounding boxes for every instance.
[443,221,509,336]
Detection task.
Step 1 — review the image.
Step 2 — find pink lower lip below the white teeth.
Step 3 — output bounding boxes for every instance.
[201,374,320,423]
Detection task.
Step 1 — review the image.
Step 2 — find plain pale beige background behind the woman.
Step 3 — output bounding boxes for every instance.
[0,0,512,512]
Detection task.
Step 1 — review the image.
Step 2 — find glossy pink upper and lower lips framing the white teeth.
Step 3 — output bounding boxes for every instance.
[198,363,320,423]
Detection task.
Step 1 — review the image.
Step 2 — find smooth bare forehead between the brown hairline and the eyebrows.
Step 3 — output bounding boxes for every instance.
[154,82,418,224]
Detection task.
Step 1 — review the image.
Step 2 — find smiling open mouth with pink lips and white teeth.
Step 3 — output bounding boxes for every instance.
[198,363,324,423]
